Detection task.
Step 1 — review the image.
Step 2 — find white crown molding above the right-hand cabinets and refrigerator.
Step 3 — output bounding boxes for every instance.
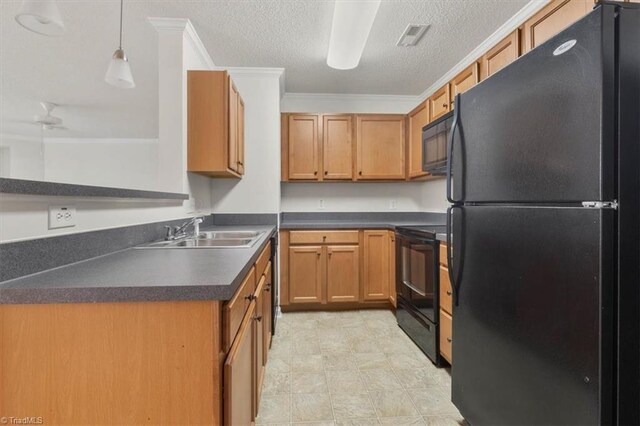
[417,0,547,102]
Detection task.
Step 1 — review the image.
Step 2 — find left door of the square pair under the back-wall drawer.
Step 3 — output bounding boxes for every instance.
[289,246,323,303]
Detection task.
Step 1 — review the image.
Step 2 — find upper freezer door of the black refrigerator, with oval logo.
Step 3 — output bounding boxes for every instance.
[451,7,615,203]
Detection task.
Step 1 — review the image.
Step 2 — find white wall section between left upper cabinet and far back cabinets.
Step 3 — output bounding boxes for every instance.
[211,68,283,213]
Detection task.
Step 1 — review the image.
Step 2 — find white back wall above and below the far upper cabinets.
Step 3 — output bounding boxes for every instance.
[281,93,448,212]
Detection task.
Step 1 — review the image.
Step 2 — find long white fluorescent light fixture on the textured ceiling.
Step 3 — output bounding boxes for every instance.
[327,0,380,70]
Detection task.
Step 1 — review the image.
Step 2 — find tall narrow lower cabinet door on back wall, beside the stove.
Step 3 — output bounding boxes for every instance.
[363,231,389,300]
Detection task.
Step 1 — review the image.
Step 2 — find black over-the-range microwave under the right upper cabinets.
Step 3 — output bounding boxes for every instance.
[422,111,453,175]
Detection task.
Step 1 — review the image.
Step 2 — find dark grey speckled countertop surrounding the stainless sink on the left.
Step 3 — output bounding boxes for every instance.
[0,226,276,304]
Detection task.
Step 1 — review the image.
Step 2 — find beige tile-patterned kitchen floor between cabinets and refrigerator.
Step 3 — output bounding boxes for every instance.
[256,310,466,426]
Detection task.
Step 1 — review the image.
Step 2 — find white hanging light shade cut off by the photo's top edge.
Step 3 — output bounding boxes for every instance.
[16,0,64,36]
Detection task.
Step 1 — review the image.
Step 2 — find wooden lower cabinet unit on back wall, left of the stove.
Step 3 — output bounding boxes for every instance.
[280,230,396,310]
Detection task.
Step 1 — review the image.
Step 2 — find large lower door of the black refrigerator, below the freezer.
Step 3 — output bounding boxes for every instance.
[449,206,615,425]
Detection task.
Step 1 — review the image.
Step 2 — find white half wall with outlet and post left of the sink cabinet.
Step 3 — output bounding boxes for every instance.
[0,19,215,242]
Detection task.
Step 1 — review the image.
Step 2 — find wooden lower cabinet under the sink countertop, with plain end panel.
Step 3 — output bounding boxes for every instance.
[0,241,273,425]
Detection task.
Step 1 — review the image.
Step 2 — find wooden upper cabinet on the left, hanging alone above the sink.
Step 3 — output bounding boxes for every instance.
[187,71,244,177]
